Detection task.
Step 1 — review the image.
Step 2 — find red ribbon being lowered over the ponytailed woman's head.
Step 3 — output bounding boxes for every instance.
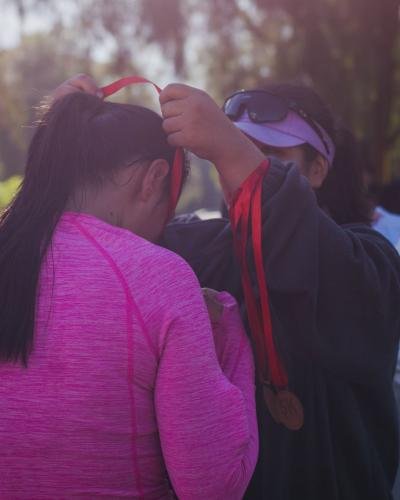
[101,76,185,218]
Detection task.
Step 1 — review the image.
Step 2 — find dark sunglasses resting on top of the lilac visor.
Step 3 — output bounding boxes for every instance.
[222,90,330,154]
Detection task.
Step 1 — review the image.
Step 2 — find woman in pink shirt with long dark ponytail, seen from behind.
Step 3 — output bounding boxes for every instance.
[0,93,258,500]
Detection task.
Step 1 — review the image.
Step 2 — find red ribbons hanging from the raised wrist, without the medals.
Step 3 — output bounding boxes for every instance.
[230,160,288,389]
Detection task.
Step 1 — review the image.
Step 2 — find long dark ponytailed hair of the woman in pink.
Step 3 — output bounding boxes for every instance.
[0,92,174,365]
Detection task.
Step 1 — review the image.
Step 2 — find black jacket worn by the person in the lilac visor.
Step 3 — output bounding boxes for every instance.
[163,160,400,500]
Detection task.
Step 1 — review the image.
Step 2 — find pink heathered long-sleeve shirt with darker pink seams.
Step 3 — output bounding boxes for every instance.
[0,213,258,500]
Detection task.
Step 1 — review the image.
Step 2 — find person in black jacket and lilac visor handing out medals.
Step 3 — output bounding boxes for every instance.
[54,74,400,500]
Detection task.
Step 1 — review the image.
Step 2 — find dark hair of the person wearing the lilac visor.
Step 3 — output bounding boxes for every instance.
[265,83,372,224]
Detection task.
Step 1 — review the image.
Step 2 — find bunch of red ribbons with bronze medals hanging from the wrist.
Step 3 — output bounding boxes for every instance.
[230,160,304,430]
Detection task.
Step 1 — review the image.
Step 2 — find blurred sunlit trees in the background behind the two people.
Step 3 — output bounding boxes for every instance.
[0,0,400,211]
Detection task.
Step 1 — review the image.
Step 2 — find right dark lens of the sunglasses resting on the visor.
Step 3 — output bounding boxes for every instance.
[247,92,288,123]
